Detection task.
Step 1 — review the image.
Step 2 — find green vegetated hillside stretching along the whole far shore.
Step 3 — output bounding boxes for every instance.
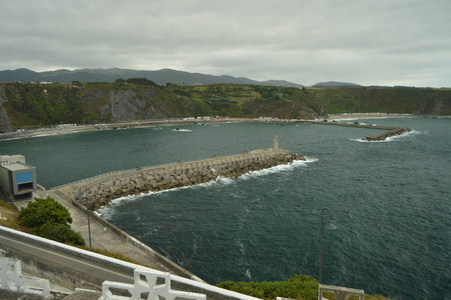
[3,78,451,128]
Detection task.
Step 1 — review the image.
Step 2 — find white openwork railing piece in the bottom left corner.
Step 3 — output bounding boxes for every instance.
[0,257,50,297]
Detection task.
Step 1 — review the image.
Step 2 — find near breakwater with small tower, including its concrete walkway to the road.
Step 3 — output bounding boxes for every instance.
[15,134,305,282]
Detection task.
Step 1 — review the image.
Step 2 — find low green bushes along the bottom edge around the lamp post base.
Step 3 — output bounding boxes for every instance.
[217,275,394,300]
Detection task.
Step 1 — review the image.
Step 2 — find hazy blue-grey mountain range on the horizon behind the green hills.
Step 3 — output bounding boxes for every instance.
[0,68,359,87]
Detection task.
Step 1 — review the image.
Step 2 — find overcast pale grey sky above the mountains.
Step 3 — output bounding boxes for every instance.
[0,0,451,87]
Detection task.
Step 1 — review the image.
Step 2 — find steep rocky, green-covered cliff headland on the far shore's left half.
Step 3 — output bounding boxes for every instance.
[0,83,211,132]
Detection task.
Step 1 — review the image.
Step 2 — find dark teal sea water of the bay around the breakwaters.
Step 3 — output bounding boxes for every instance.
[0,119,451,299]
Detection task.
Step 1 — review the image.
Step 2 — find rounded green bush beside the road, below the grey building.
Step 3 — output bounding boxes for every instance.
[18,196,85,246]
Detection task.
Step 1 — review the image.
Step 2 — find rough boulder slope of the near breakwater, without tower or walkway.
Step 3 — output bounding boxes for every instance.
[79,149,305,210]
